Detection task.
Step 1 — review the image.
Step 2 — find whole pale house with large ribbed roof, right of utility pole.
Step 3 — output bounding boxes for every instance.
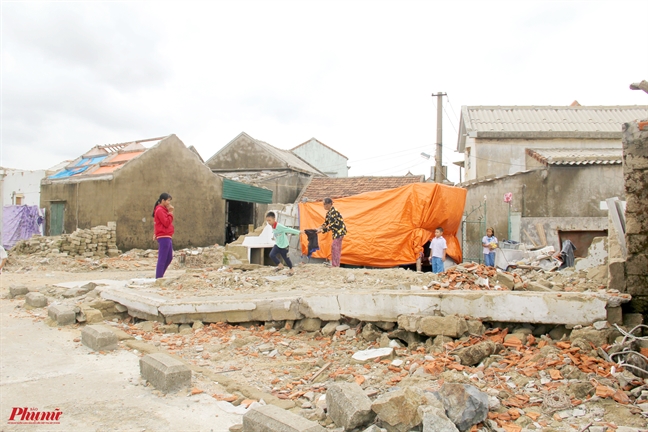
[457,103,648,261]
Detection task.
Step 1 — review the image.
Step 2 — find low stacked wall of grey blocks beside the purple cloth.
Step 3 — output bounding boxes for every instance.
[11,222,120,258]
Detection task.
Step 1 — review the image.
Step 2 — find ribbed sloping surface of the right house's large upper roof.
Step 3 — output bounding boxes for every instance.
[464,106,648,132]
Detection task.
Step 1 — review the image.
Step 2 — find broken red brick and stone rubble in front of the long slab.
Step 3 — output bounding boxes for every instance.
[104,316,648,432]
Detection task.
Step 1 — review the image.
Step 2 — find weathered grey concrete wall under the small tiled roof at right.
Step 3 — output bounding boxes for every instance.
[464,164,624,250]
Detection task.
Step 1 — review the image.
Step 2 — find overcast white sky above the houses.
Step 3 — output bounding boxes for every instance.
[0,0,648,182]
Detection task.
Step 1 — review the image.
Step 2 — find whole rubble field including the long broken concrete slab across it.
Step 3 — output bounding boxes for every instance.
[1,236,648,432]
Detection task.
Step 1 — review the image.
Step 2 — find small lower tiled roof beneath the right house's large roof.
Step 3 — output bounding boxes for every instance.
[527,148,623,165]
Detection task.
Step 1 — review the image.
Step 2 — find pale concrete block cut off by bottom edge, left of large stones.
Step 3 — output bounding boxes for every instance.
[243,405,326,432]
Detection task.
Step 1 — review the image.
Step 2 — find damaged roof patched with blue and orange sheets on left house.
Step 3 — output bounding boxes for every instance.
[48,137,165,180]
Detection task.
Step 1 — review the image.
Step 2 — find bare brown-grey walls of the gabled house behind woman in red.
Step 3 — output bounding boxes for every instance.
[41,135,225,250]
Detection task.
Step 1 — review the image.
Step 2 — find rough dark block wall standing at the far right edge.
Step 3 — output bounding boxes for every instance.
[623,119,648,313]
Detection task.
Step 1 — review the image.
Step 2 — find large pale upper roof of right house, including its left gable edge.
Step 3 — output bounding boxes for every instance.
[457,105,648,152]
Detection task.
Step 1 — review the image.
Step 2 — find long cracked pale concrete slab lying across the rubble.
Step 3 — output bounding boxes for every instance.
[92,281,630,325]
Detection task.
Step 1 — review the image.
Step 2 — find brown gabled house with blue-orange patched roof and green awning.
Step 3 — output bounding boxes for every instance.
[41,135,272,250]
